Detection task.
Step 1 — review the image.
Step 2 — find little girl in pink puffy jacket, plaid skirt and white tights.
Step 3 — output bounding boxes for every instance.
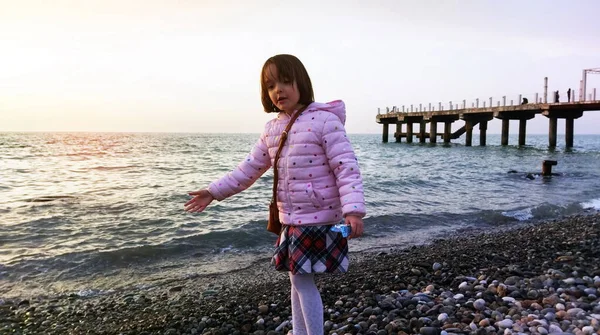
[185,55,365,335]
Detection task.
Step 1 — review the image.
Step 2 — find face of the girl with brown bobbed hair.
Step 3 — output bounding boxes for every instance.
[265,64,300,114]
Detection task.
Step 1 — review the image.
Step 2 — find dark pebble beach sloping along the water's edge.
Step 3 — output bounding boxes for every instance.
[0,213,600,335]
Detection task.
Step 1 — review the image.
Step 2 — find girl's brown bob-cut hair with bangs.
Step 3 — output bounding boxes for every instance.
[260,54,315,113]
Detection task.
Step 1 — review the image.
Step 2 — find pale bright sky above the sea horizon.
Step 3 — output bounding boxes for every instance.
[0,0,600,134]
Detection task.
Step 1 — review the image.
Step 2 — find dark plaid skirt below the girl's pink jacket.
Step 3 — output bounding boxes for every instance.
[271,225,349,274]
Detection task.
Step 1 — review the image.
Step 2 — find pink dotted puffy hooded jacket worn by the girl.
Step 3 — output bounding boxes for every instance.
[208,100,366,225]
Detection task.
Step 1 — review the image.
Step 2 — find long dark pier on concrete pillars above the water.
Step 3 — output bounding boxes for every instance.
[376,75,600,148]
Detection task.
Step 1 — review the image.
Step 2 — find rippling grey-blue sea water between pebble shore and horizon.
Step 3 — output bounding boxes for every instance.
[0,133,600,298]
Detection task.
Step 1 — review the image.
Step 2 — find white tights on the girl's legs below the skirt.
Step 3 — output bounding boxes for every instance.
[290,272,323,335]
